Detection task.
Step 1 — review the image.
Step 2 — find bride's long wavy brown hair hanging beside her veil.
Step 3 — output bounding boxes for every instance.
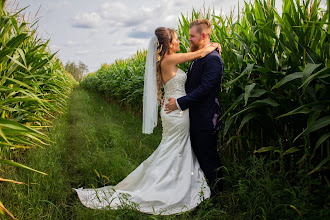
[155,27,175,100]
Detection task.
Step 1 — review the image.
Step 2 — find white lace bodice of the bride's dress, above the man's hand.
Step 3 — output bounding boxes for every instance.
[164,69,187,98]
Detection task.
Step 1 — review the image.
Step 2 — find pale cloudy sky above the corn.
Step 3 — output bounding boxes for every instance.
[7,0,326,72]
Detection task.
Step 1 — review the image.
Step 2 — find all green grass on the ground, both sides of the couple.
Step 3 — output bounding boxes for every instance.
[0,87,330,219]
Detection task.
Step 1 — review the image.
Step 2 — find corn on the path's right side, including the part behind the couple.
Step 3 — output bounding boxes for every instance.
[81,0,330,180]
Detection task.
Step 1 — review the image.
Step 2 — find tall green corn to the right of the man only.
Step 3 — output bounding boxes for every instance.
[209,0,330,177]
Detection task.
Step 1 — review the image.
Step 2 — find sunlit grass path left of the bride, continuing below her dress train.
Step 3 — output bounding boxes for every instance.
[0,87,224,219]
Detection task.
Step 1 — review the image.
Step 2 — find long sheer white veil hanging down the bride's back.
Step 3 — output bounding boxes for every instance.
[142,35,158,134]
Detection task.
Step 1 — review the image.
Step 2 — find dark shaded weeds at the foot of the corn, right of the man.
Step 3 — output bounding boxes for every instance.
[220,155,330,219]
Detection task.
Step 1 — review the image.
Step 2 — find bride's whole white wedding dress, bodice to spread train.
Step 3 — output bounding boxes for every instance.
[75,69,211,215]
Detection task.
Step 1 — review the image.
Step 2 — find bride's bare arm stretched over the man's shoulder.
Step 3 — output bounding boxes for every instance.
[164,43,220,65]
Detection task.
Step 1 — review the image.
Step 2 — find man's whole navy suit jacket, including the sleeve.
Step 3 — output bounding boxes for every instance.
[177,51,224,131]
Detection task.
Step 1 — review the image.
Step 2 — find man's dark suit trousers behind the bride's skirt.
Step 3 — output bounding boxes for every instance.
[190,129,223,194]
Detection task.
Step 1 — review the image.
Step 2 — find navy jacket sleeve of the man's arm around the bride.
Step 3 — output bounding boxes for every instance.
[177,54,223,110]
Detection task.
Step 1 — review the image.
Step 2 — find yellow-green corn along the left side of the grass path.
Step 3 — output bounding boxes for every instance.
[0,0,75,218]
